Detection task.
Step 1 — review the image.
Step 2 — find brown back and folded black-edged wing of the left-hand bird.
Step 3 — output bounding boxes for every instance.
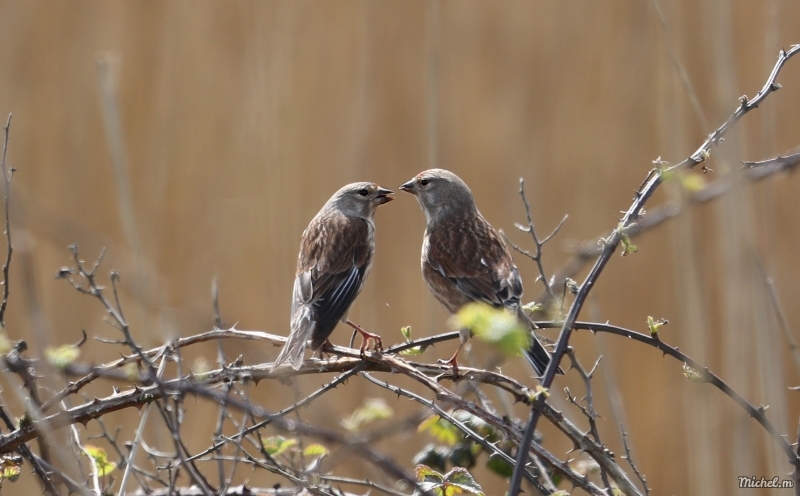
[293,215,373,348]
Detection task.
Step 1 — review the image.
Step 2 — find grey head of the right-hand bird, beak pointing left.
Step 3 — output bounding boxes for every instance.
[400,169,476,225]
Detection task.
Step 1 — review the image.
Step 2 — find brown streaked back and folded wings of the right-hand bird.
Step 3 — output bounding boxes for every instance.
[425,214,522,307]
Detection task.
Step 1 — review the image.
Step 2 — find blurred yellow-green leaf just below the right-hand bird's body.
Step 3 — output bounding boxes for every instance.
[450,303,531,356]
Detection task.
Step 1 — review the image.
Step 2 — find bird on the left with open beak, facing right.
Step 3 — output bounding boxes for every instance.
[272,182,394,370]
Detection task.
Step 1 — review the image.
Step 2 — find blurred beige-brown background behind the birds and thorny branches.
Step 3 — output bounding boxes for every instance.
[0,0,800,495]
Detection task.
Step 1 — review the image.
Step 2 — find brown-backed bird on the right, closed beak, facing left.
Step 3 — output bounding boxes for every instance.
[400,169,563,377]
